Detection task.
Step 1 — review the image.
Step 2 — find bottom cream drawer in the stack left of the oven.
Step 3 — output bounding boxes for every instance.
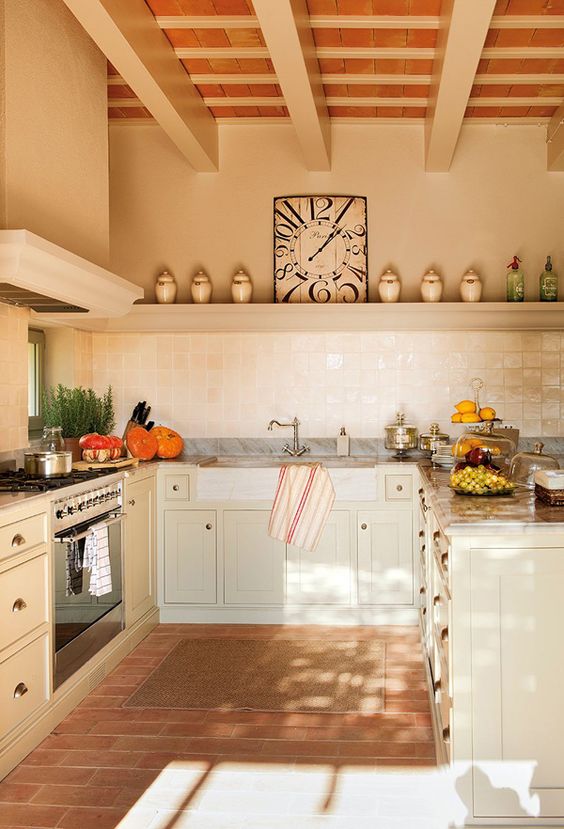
[0,634,49,735]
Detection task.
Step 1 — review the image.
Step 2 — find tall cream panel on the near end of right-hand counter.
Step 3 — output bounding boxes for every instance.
[471,548,564,818]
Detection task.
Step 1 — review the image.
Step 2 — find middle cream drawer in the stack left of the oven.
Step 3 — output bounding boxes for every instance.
[0,554,48,651]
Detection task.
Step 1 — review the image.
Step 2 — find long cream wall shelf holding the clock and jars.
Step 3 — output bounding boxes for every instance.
[59,302,564,333]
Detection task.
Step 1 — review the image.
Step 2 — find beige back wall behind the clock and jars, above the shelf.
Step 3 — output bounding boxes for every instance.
[110,125,564,302]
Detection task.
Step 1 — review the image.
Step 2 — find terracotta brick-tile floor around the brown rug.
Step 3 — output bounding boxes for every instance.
[0,625,460,829]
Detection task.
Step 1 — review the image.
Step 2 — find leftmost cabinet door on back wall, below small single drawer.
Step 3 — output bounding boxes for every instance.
[164,510,217,604]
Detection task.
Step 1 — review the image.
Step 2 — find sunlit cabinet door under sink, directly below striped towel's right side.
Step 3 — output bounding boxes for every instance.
[287,510,351,604]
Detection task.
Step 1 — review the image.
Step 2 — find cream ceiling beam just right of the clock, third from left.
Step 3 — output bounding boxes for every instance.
[425,0,495,172]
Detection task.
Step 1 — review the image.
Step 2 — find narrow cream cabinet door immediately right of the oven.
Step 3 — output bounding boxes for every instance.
[124,475,156,625]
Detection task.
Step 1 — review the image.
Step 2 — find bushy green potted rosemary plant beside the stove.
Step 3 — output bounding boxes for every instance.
[43,383,116,461]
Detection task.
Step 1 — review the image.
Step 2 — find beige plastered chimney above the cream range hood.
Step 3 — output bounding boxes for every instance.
[0,0,109,266]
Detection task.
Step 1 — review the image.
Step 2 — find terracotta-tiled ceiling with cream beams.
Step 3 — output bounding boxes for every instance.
[60,0,564,171]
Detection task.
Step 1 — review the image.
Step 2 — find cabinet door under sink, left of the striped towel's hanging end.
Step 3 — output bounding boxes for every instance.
[223,510,286,604]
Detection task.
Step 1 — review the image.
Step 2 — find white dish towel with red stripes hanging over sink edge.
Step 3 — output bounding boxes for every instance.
[268,463,335,551]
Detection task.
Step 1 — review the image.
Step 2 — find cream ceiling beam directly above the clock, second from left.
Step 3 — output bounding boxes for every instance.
[253,0,331,170]
